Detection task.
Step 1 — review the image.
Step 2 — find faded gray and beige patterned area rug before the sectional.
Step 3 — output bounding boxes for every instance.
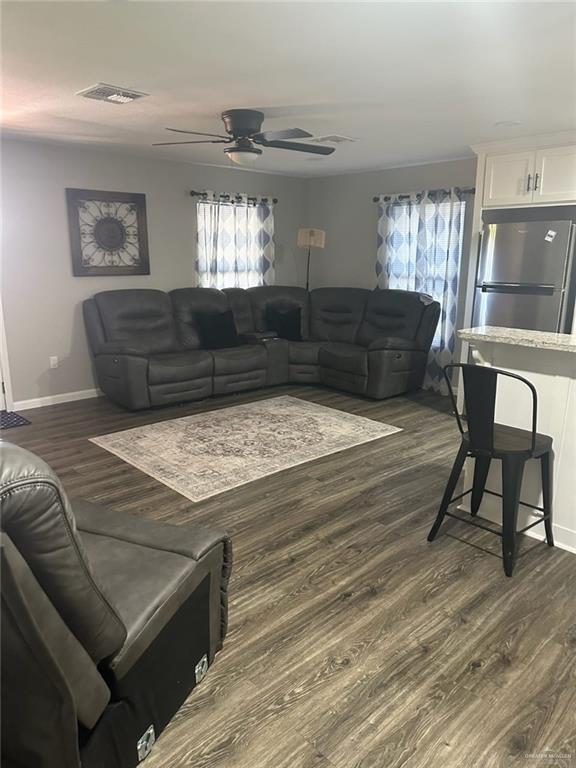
[91,396,401,501]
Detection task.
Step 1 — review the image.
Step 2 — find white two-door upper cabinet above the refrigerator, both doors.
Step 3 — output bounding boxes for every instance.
[482,146,576,208]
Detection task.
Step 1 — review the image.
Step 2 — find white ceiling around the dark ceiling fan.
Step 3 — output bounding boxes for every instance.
[2,1,576,176]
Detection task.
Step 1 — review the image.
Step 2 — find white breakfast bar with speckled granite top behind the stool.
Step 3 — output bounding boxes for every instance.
[458,326,576,552]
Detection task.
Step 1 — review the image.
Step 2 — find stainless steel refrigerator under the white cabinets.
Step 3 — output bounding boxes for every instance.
[473,221,576,333]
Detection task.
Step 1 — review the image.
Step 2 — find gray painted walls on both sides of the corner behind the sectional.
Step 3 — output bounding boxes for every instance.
[2,145,476,408]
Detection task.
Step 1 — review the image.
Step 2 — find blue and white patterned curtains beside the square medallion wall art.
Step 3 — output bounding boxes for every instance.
[196,193,274,288]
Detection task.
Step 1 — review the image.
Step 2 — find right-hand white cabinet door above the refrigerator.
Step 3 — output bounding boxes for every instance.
[533,147,576,203]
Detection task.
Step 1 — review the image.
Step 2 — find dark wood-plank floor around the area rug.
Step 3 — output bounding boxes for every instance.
[3,387,576,768]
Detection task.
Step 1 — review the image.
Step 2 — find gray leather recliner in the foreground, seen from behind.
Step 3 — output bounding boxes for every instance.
[0,442,231,768]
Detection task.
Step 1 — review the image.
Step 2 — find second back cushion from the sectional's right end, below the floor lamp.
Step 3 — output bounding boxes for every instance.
[310,288,370,344]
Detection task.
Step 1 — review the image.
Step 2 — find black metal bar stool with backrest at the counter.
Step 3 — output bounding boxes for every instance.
[428,363,554,576]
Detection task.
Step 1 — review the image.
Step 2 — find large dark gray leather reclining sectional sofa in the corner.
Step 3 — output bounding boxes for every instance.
[84,286,440,410]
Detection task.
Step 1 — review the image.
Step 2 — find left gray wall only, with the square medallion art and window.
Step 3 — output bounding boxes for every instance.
[2,141,308,401]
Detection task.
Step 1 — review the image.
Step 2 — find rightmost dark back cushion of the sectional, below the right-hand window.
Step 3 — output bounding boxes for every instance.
[357,288,432,346]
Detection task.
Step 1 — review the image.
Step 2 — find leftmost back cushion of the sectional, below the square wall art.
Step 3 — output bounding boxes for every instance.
[94,289,179,354]
